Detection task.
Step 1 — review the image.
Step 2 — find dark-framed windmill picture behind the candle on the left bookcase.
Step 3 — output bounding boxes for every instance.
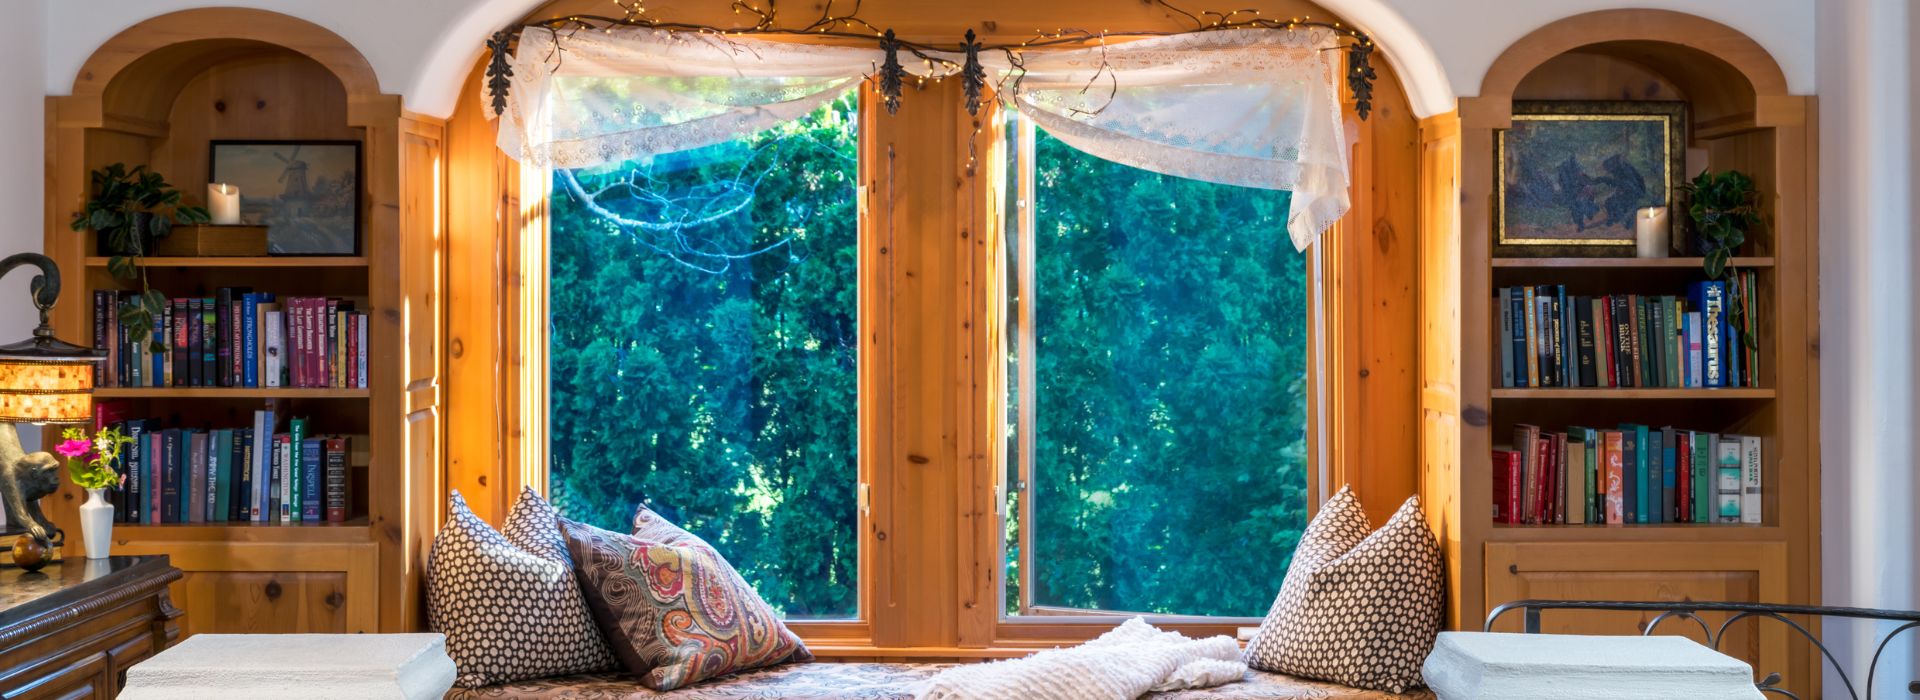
[207,140,361,255]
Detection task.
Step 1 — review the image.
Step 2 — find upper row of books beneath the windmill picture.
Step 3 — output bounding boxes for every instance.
[94,288,367,389]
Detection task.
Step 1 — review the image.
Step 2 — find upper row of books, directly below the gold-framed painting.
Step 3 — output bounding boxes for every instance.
[1496,270,1761,387]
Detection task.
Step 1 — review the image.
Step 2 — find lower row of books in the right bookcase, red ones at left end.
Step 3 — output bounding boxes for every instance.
[1494,424,1764,525]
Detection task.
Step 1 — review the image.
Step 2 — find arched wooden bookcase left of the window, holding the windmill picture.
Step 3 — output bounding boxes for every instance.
[46,8,442,635]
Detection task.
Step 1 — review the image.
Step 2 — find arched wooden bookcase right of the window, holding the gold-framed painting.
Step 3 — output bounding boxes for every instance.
[1423,10,1820,696]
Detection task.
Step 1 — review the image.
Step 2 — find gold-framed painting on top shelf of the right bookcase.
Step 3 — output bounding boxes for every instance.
[1494,102,1686,257]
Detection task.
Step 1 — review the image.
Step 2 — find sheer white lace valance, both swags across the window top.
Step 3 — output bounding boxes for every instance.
[499,27,1348,249]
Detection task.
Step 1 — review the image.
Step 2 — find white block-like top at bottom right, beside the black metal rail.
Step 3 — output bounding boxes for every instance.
[1421,633,1761,700]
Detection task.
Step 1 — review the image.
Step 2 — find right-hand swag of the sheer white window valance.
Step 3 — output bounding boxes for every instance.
[1002,27,1348,249]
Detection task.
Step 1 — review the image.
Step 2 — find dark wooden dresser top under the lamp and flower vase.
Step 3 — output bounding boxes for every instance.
[0,554,175,629]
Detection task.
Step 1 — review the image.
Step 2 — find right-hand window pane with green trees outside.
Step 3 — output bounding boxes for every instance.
[1006,122,1309,618]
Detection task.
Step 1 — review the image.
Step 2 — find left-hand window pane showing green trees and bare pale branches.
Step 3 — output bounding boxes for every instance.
[549,96,858,618]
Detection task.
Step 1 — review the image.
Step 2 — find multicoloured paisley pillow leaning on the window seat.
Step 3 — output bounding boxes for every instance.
[561,508,814,690]
